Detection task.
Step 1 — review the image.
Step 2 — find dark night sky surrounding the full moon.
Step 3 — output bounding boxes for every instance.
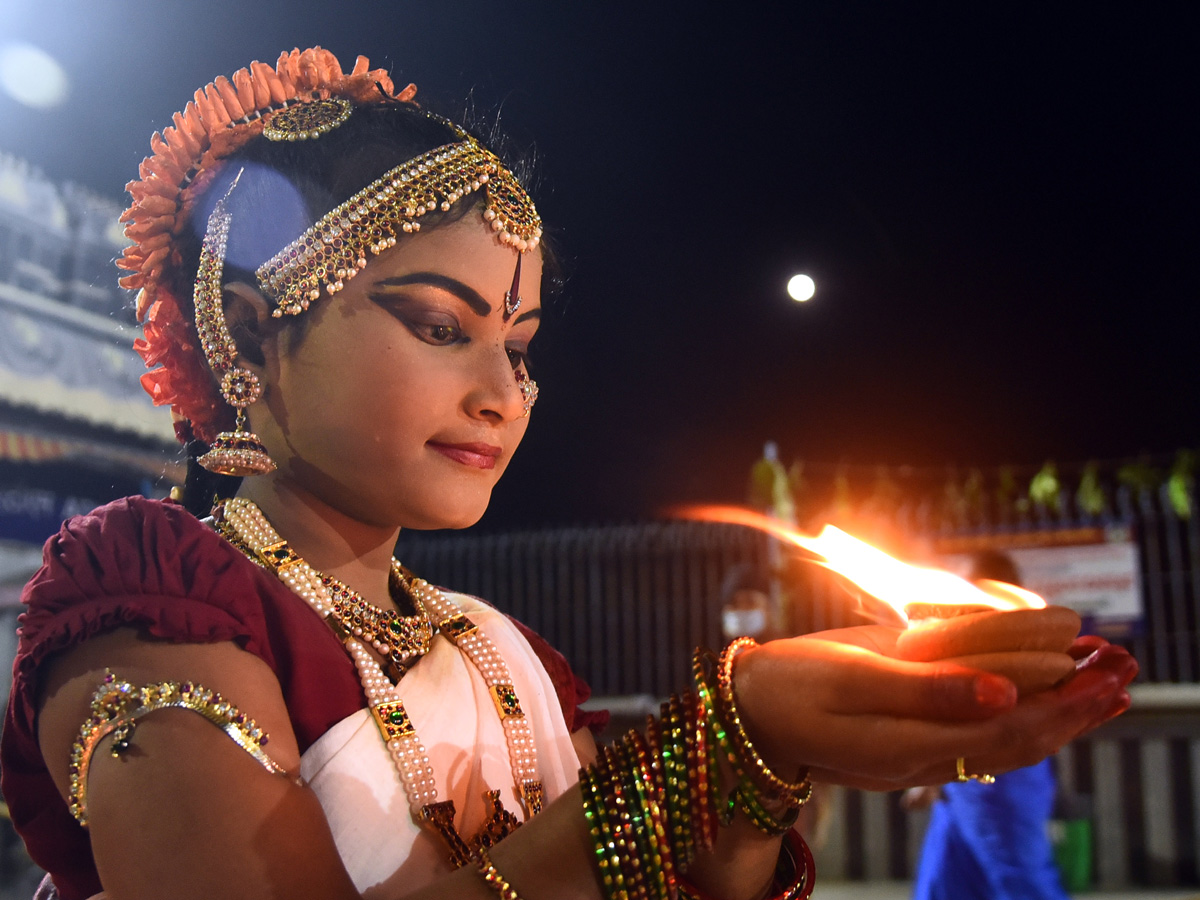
[0,0,1200,528]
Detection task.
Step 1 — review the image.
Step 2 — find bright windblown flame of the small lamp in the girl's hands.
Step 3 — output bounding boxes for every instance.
[682,506,1046,623]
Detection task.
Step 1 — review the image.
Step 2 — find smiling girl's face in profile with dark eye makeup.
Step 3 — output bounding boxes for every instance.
[248,214,541,528]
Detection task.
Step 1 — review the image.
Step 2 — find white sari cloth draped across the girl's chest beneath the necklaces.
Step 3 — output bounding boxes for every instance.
[300,593,580,898]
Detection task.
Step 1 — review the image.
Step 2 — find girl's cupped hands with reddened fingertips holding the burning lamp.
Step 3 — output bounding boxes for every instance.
[734,626,1138,790]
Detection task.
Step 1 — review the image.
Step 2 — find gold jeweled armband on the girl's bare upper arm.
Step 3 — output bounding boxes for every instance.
[70,671,288,826]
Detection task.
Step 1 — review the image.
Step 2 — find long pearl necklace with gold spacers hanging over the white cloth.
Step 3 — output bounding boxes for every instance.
[222,497,542,868]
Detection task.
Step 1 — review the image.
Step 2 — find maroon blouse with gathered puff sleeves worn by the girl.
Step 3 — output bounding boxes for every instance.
[0,497,607,900]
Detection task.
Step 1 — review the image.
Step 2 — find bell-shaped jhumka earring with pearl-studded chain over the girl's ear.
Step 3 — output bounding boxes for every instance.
[192,172,275,476]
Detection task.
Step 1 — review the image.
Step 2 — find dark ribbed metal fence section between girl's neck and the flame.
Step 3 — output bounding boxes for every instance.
[397,522,767,696]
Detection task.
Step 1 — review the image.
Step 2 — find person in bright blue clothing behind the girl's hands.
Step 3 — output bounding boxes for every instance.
[905,552,1068,900]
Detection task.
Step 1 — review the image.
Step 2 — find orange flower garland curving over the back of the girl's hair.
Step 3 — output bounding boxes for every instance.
[116,47,416,442]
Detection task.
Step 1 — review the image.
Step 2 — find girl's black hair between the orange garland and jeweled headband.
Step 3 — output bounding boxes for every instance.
[172,102,557,515]
